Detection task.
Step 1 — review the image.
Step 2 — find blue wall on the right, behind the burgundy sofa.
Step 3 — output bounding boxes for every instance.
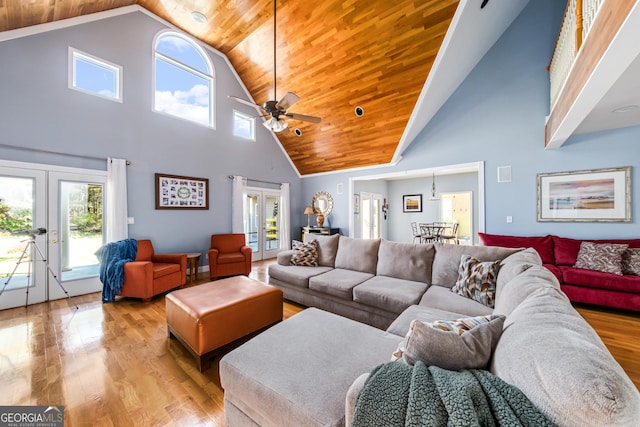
[303,0,640,238]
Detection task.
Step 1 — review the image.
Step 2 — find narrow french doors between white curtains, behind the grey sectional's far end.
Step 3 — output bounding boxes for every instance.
[244,188,282,261]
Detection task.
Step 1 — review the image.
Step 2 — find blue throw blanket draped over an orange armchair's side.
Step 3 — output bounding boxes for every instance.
[96,239,138,303]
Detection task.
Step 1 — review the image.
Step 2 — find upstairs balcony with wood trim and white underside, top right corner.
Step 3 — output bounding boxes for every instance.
[545,0,640,148]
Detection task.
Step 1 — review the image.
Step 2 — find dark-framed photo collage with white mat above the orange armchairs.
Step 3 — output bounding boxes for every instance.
[155,173,209,209]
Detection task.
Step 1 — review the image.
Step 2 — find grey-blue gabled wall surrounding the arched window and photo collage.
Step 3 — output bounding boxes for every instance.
[0,11,306,262]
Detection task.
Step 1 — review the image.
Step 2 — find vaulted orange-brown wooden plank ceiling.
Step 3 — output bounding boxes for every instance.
[0,0,458,175]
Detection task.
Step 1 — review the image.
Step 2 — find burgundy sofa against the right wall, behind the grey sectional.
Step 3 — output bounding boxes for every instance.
[478,233,640,311]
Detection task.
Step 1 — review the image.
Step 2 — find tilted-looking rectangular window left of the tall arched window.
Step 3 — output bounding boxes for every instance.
[69,47,122,102]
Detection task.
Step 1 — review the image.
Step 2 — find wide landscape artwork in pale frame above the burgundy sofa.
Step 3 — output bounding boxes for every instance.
[537,166,631,222]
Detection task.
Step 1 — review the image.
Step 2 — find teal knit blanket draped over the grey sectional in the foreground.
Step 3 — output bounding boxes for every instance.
[352,362,553,427]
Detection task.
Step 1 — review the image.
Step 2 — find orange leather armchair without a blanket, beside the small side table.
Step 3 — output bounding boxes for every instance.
[208,234,252,280]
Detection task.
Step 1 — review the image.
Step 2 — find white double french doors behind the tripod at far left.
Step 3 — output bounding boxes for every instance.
[0,162,106,309]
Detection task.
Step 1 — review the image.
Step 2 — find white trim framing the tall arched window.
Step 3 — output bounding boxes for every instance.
[151,30,216,130]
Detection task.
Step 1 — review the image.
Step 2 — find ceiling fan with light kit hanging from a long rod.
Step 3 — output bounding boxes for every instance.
[229,0,322,132]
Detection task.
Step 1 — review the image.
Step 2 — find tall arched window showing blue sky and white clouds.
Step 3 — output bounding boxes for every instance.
[153,31,214,128]
